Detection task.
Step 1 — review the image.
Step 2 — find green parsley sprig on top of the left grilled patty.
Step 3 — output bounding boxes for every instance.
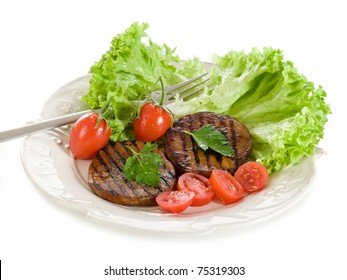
[124,142,164,186]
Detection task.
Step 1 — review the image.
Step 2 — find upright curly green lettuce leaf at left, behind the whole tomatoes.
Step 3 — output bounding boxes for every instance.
[82,22,202,141]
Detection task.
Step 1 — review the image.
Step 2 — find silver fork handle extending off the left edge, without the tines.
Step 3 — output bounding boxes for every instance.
[0,110,91,143]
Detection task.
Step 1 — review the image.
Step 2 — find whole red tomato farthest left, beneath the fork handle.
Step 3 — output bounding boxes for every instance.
[70,113,111,159]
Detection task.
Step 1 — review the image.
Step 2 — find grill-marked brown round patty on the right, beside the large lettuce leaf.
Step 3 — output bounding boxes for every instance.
[165,112,252,176]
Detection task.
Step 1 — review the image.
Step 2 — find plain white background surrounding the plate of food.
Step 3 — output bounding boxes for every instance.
[0,0,347,280]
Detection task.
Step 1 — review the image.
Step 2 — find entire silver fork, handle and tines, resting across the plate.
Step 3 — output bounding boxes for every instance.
[0,73,211,143]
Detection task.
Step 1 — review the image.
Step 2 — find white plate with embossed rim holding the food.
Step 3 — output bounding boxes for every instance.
[21,75,315,233]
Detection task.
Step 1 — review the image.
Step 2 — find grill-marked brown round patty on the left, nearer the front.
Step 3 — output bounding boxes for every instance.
[88,141,176,206]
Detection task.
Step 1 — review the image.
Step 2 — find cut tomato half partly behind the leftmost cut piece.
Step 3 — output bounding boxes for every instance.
[177,172,214,206]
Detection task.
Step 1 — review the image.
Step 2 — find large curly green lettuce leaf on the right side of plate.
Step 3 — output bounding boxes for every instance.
[169,48,331,173]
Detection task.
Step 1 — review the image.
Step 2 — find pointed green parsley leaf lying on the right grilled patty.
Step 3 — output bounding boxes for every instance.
[185,125,235,157]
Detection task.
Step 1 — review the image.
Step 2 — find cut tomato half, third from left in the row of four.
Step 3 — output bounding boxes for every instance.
[210,169,246,204]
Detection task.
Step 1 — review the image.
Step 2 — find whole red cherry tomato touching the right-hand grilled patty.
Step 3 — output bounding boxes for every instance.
[133,103,171,142]
